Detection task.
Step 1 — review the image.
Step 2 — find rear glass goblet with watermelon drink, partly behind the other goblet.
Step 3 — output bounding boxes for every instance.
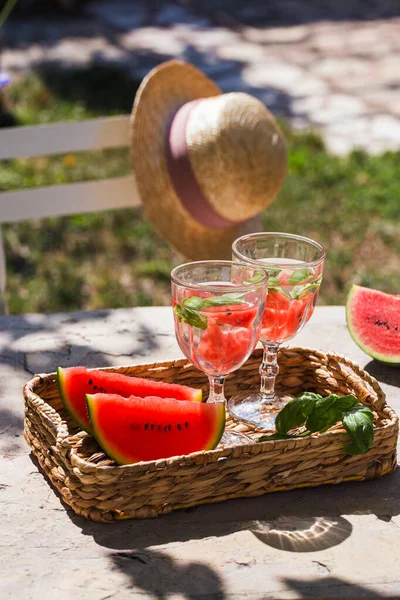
[228,233,326,429]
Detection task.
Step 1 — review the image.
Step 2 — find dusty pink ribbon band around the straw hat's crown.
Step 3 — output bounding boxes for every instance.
[166,99,236,229]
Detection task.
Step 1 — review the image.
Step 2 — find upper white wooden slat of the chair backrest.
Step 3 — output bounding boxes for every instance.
[0,115,129,160]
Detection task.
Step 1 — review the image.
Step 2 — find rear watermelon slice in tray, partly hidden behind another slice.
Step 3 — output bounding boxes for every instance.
[57,367,202,433]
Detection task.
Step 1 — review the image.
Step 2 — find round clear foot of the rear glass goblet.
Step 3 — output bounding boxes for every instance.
[228,392,287,430]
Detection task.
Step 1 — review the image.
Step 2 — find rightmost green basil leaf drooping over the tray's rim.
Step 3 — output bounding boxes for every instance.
[342,404,374,455]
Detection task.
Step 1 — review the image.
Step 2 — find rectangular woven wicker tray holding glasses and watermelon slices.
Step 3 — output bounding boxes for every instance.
[24,348,398,521]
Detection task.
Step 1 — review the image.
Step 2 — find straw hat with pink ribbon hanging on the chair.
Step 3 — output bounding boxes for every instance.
[131,60,287,260]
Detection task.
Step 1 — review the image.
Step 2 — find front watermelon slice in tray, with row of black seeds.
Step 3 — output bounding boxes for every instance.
[86,394,225,465]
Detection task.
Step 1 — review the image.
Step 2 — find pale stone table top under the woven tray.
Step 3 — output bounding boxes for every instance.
[0,307,400,600]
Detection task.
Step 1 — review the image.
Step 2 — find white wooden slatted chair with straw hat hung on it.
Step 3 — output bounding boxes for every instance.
[0,116,140,314]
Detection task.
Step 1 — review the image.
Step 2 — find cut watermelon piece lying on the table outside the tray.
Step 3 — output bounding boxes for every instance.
[346,285,400,364]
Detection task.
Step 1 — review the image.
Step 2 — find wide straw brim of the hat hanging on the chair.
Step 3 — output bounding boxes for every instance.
[130,60,260,260]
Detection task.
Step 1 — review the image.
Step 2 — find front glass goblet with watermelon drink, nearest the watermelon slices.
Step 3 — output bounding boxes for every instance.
[171,260,268,445]
